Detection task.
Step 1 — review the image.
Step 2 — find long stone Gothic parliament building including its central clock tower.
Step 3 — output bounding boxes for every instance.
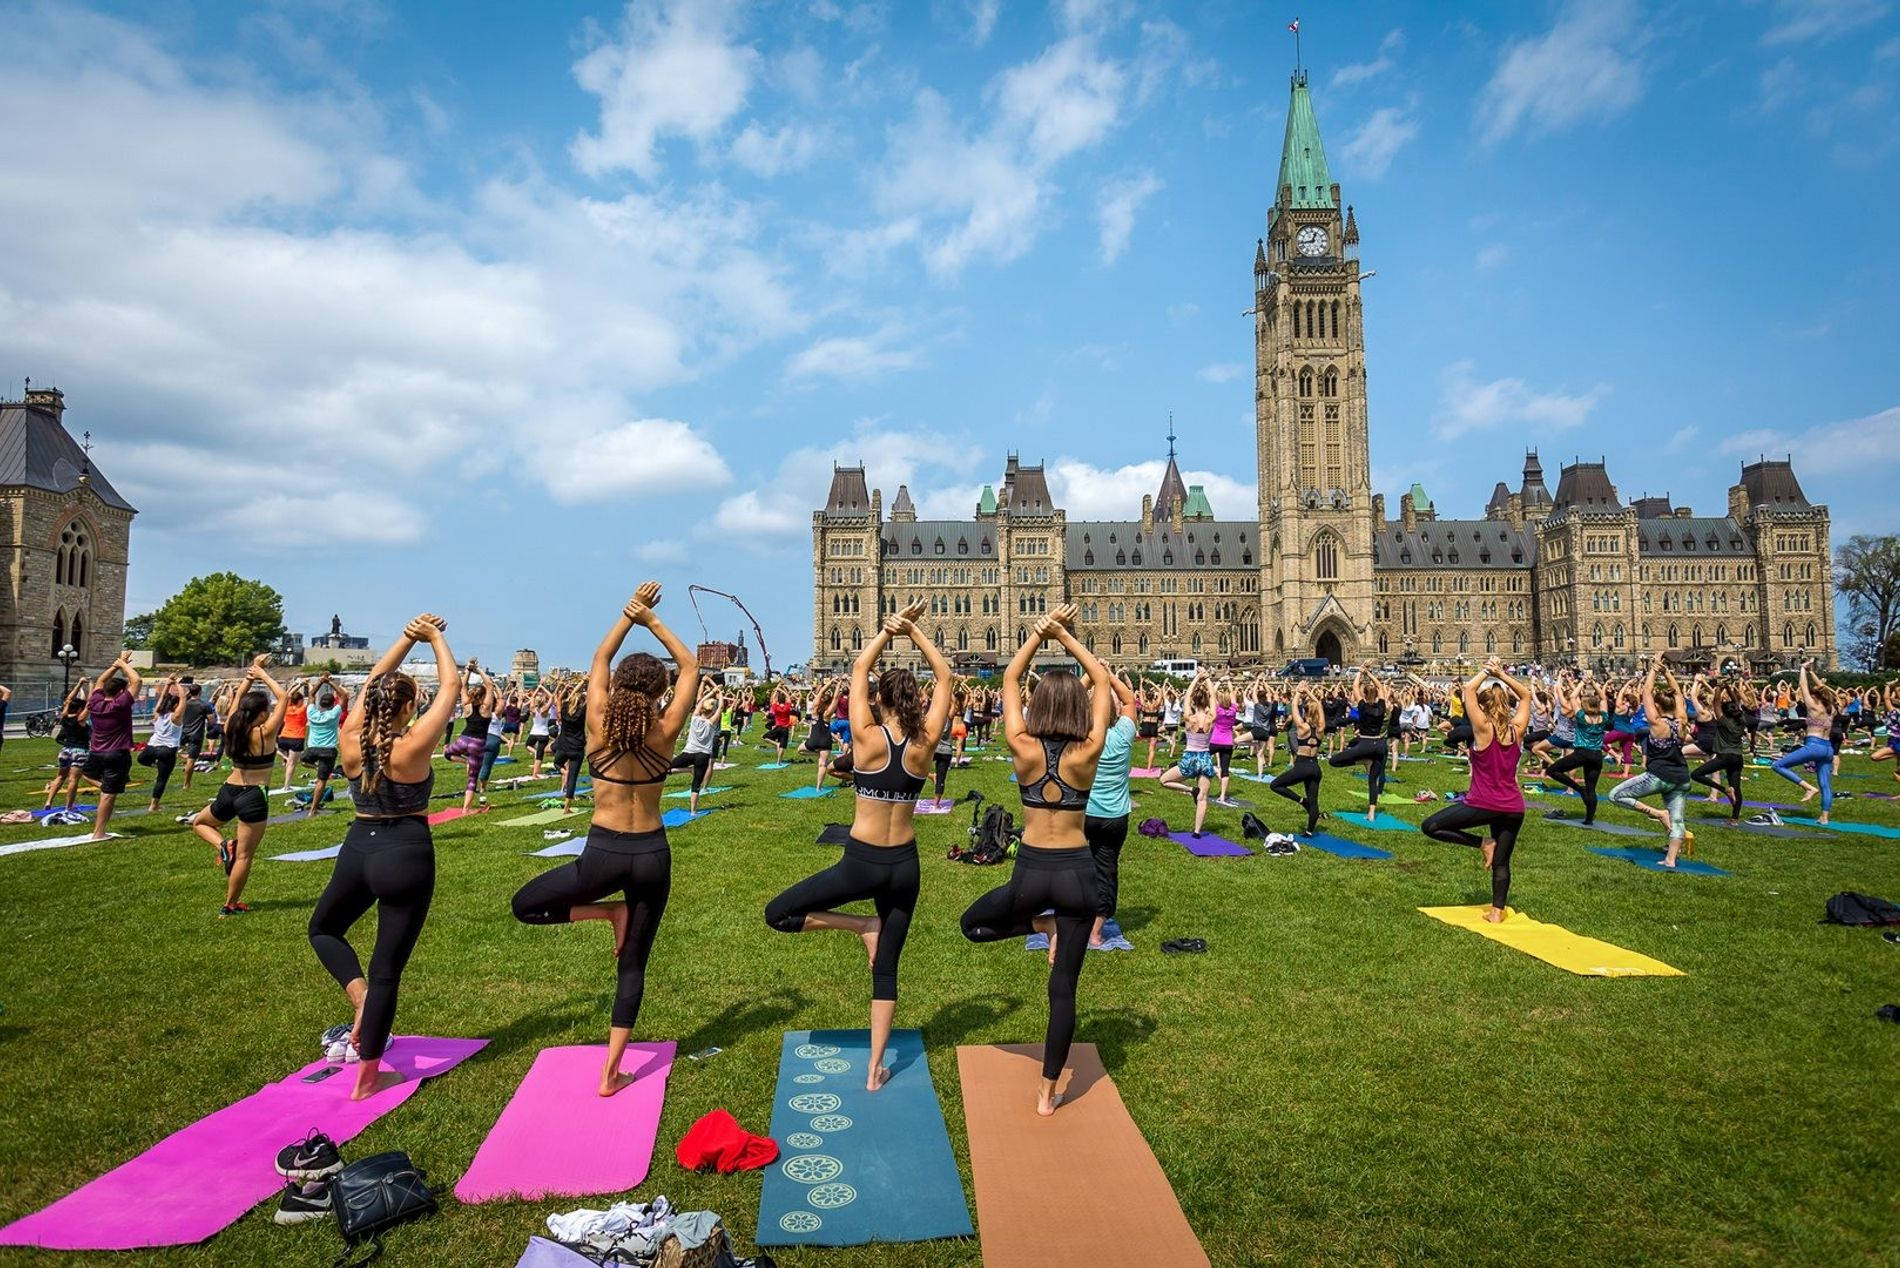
[811,72,1835,669]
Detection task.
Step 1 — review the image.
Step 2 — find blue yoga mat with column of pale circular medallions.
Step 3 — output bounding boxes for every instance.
[756,1030,975,1245]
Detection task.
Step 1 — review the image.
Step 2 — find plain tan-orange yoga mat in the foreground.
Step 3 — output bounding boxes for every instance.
[956,1044,1208,1268]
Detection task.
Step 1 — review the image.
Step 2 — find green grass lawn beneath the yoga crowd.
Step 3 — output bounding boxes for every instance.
[0,741,1900,1268]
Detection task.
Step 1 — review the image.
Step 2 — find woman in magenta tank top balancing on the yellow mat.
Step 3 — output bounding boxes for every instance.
[1419,656,1531,924]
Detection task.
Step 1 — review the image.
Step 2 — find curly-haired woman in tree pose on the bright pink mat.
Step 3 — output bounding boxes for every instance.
[515,582,699,1097]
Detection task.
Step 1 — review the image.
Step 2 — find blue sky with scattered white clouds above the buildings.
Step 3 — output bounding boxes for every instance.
[0,0,1900,665]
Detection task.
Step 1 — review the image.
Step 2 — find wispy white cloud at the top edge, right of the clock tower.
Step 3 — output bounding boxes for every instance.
[1478,0,1645,144]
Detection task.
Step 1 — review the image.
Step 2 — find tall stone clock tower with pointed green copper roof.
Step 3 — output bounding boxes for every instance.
[1254,70,1376,663]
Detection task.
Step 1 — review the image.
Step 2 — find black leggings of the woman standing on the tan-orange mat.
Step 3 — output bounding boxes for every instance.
[963,844,1100,1078]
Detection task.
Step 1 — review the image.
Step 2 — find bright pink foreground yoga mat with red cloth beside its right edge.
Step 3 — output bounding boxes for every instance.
[456,1040,675,1203]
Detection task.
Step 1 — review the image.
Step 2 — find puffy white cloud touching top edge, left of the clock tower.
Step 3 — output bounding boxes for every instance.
[572,0,758,181]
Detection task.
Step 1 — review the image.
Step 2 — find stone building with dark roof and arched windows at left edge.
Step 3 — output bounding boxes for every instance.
[0,388,139,692]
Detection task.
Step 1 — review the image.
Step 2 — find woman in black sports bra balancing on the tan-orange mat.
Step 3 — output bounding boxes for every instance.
[963,603,1115,1116]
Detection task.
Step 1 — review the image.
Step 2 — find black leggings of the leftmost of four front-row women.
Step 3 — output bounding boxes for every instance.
[310,816,435,1061]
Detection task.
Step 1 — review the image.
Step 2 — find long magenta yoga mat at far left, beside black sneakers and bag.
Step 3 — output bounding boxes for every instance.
[0,1036,488,1251]
